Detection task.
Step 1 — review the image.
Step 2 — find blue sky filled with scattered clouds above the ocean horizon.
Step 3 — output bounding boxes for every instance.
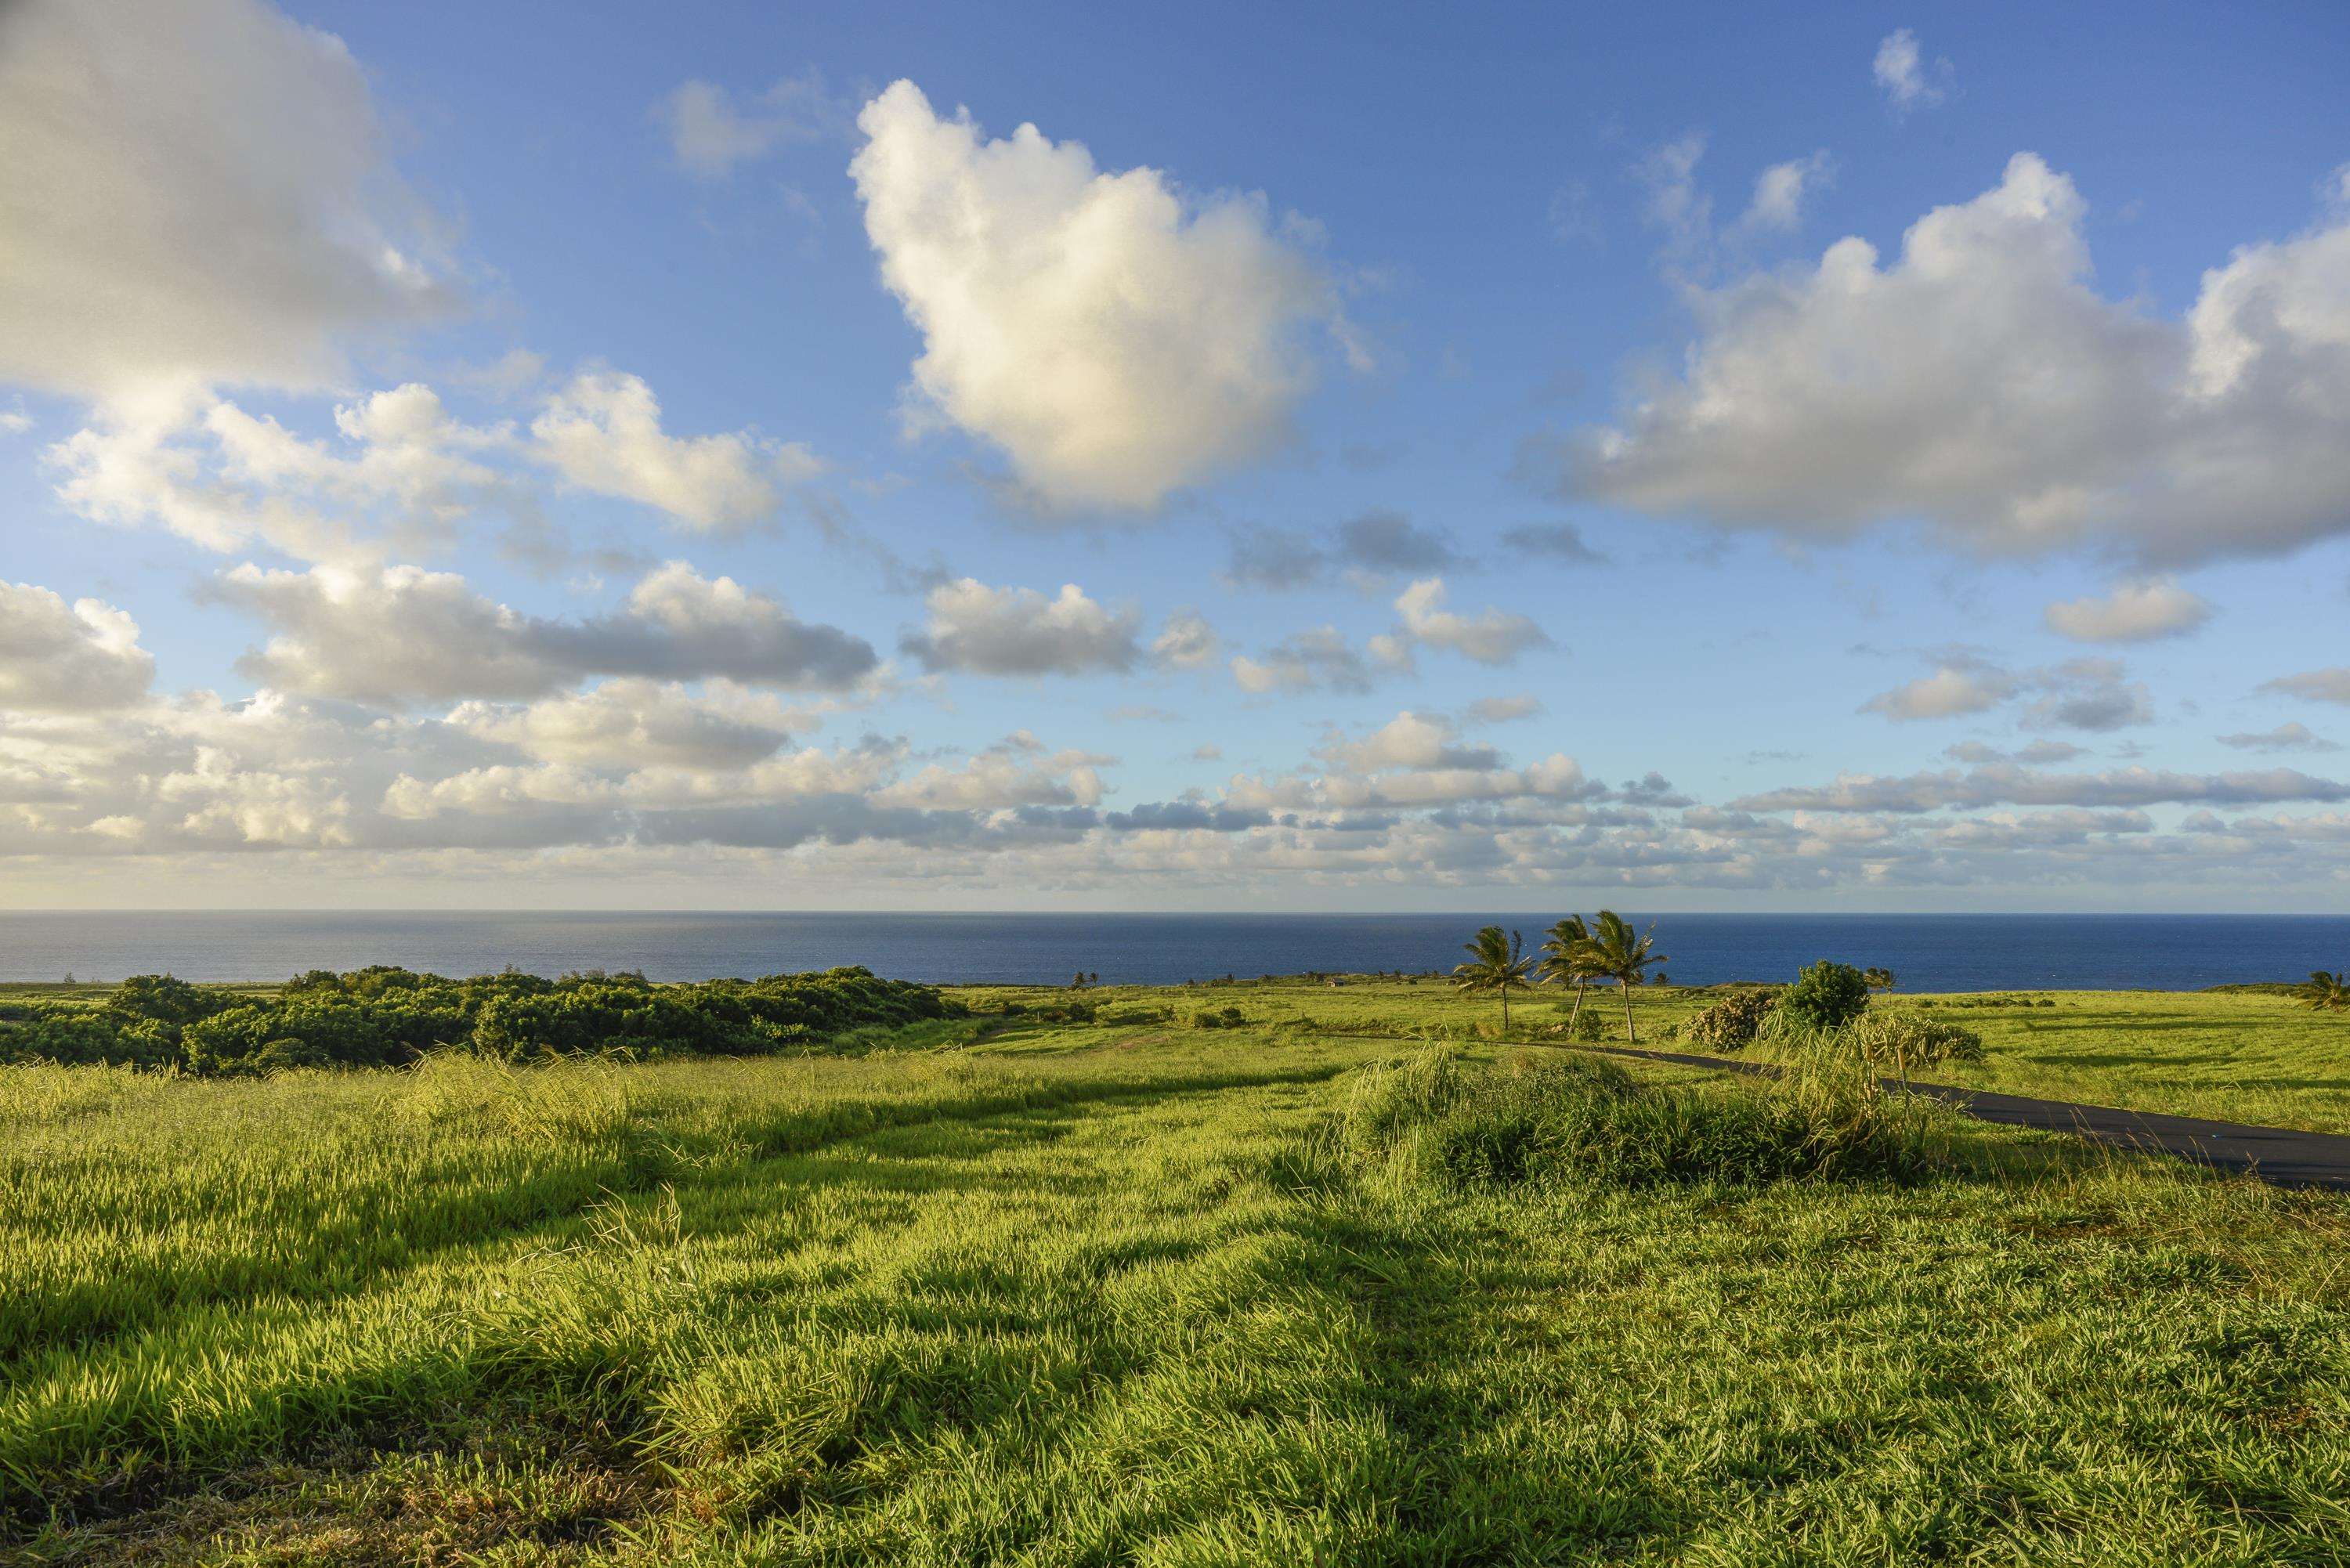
[0,0,2350,910]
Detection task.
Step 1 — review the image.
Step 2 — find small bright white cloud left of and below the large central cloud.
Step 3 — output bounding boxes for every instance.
[531,371,822,531]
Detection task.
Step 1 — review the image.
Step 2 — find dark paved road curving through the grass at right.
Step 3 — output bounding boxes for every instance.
[1591,1046,2350,1192]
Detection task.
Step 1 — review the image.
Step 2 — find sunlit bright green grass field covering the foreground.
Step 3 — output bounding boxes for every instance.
[0,981,2350,1566]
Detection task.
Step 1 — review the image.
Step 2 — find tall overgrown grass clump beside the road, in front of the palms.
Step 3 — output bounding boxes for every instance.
[1337,1049,1948,1187]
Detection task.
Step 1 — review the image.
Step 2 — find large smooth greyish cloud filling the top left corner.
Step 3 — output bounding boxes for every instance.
[0,0,451,399]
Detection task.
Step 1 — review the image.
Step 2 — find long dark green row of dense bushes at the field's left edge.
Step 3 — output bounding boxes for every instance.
[0,966,964,1072]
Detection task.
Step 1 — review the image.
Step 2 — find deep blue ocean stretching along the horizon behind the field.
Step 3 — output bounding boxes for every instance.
[0,912,2350,990]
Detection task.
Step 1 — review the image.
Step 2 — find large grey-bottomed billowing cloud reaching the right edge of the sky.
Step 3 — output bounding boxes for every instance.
[1525,153,2350,564]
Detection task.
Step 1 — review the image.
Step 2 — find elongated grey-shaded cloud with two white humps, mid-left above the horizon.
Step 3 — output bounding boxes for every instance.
[207,562,879,705]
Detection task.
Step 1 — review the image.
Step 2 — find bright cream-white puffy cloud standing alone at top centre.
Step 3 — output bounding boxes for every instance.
[851,82,1335,510]
